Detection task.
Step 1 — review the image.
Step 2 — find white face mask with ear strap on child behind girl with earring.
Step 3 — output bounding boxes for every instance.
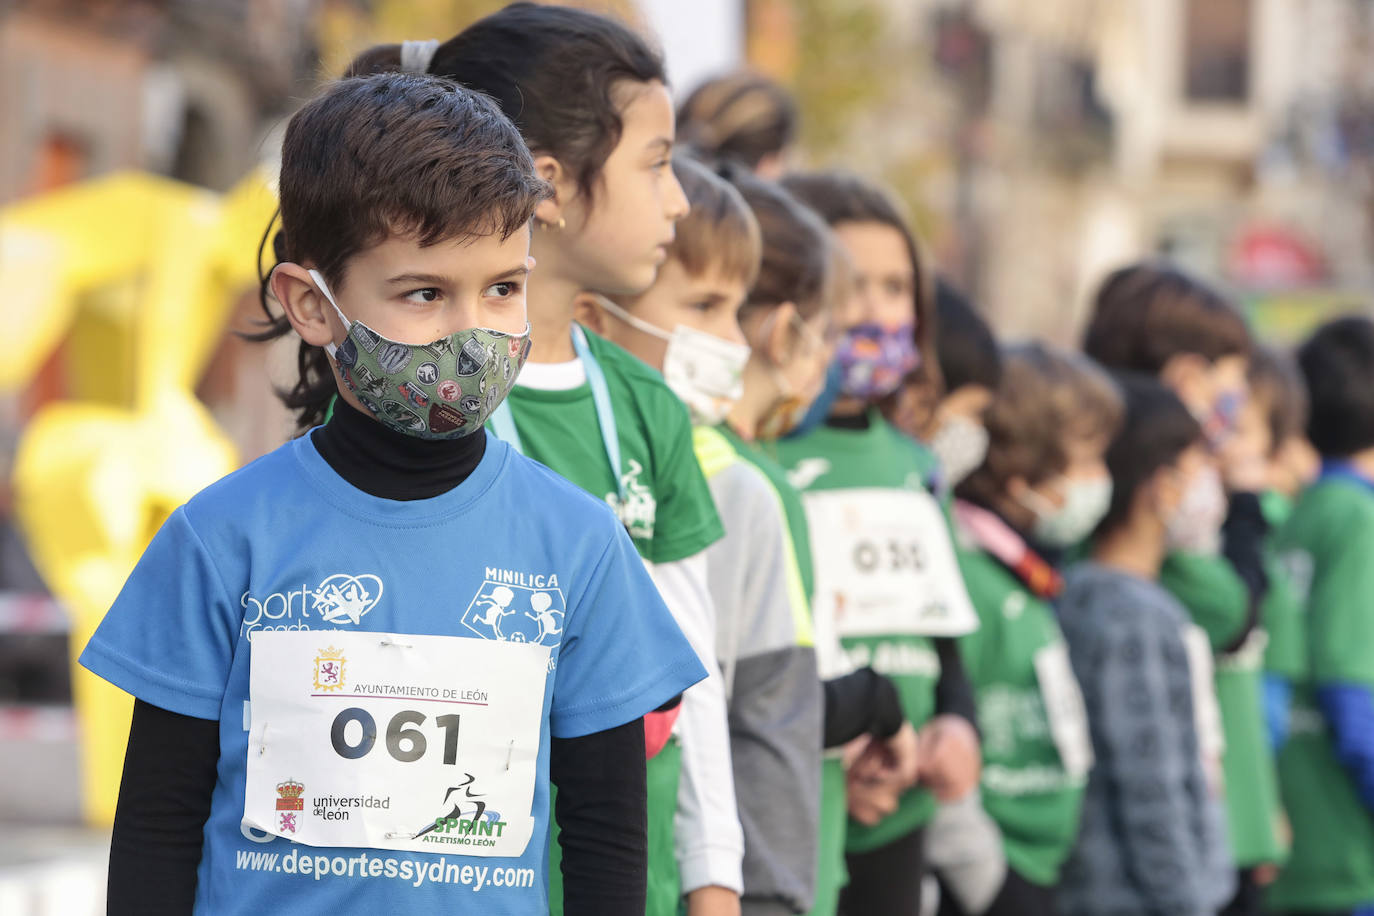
[596,295,750,426]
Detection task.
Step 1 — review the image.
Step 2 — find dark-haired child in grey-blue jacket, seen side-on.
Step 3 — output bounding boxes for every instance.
[1059,378,1234,916]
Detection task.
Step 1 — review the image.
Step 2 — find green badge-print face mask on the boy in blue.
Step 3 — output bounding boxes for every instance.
[311,271,529,439]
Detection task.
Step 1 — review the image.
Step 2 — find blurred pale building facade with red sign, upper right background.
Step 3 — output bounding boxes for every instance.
[750,0,1374,341]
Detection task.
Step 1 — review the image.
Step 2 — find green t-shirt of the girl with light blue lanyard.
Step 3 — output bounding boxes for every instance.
[507,325,724,563]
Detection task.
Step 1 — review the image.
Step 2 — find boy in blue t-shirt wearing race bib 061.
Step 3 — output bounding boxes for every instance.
[81,74,705,913]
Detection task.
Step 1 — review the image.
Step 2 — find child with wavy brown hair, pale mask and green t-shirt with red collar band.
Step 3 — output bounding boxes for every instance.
[930,343,1123,916]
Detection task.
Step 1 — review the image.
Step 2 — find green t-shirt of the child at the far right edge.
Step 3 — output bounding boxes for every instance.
[1268,477,1374,911]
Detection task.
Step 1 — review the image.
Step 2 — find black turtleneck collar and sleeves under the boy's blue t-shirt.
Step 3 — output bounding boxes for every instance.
[107,400,649,916]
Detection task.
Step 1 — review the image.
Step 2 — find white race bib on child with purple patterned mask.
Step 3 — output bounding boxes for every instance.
[805,489,978,678]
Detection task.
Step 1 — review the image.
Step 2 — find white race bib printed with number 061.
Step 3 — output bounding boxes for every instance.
[243,630,550,856]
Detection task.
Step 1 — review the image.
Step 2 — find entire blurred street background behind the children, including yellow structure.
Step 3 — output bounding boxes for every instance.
[0,0,1374,915]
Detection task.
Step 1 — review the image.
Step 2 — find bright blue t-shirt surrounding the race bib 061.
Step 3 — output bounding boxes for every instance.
[81,435,706,915]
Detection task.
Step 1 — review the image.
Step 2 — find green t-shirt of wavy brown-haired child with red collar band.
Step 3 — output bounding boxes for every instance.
[959,549,1091,886]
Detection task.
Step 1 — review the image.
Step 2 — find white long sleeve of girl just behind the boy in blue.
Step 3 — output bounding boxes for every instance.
[646,552,745,894]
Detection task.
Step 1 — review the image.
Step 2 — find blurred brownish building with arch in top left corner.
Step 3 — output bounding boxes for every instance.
[0,0,316,203]
